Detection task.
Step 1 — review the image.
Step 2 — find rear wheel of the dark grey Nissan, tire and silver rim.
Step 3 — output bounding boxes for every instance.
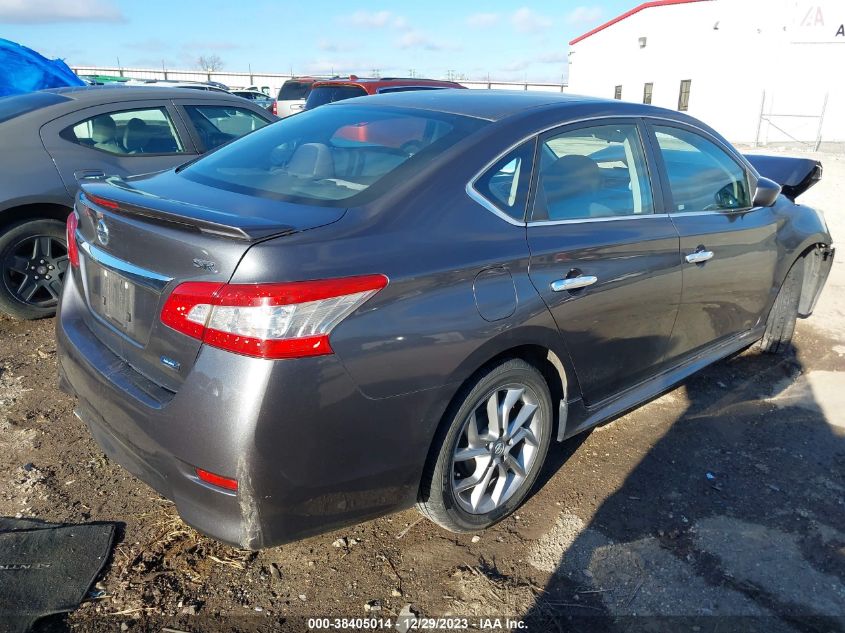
[417,359,553,532]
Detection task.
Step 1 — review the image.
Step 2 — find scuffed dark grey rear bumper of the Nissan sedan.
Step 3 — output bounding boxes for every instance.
[57,275,451,549]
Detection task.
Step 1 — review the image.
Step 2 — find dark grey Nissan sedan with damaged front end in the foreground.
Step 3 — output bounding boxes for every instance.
[57,90,833,548]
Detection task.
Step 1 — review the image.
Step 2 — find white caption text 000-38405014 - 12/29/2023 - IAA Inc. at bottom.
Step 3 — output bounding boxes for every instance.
[307,615,527,632]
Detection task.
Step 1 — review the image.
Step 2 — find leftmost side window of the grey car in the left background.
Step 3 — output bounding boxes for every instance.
[61,108,184,155]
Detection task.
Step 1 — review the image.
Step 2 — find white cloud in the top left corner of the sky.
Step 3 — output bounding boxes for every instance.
[0,0,126,24]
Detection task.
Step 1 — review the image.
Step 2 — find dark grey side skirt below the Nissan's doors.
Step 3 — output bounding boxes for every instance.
[557,324,765,442]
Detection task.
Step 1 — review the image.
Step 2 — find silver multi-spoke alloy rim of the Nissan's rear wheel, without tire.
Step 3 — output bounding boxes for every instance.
[452,384,544,514]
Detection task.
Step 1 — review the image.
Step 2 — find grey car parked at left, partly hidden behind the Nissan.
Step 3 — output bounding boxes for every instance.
[0,86,275,319]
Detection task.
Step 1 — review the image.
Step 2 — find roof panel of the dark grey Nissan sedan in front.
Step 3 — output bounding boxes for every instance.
[328,89,677,121]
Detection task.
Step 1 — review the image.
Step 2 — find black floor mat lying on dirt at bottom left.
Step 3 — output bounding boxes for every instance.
[0,517,116,633]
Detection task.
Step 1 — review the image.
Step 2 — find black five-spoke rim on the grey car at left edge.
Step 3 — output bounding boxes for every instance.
[2,235,68,308]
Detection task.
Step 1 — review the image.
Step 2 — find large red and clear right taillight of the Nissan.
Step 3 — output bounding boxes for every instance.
[161,275,387,358]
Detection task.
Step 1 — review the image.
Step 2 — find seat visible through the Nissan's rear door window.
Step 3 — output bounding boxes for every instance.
[535,154,611,220]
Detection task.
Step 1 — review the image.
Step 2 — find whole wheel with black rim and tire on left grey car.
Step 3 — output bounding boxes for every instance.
[0,219,68,320]
